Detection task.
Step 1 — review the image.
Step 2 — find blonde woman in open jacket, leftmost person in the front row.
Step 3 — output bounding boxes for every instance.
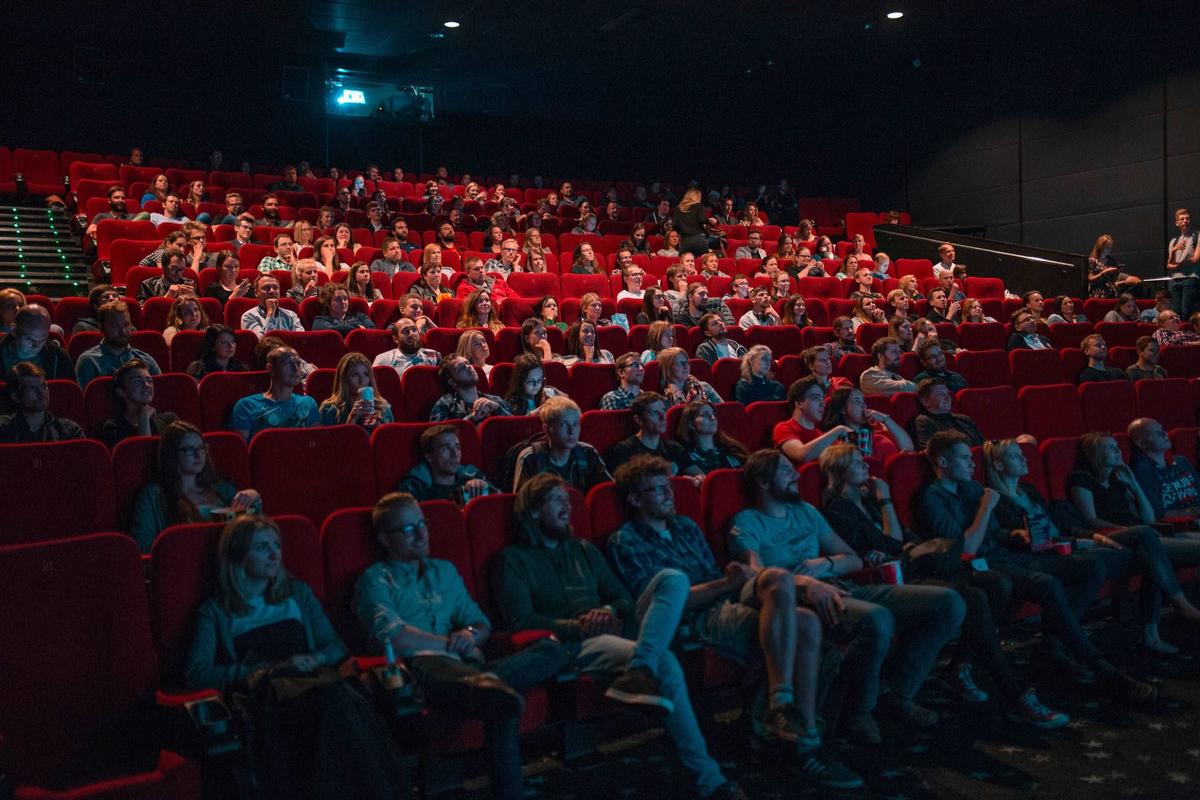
[186,515,407,800]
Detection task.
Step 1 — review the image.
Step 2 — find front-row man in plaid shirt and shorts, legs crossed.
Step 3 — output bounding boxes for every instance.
[608,455,863,789]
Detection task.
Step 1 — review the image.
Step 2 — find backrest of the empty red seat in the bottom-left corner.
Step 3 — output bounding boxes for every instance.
[0,534,158,794]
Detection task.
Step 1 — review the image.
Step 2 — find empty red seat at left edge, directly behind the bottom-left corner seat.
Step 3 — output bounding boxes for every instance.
[0,438,116,545]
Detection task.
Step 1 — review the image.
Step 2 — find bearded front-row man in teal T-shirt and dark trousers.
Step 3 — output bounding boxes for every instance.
[728,450,966,744]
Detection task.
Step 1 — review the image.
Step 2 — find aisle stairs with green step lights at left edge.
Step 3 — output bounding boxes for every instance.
[0,204,89,297]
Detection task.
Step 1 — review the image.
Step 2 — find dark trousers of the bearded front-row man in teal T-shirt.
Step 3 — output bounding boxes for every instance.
[842,584,966,714]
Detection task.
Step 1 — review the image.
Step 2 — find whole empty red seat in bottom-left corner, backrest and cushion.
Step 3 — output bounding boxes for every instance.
[0,534,200,800]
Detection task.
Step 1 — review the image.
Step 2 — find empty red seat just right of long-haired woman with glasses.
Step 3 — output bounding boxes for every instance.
[250,425,374,524]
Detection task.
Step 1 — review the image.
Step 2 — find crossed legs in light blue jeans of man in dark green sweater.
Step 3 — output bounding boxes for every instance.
[575,570,725,795]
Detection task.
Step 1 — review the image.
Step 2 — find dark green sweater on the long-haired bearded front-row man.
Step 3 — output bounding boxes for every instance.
[492,509,634,642]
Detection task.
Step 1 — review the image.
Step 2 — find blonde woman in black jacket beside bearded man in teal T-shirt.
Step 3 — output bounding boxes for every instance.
[821,444,1070,730]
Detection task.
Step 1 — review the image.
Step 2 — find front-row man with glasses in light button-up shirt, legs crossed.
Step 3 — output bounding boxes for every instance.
[354,492,566,798]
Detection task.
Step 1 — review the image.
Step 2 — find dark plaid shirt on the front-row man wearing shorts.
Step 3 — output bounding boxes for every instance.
[608,516,721,597]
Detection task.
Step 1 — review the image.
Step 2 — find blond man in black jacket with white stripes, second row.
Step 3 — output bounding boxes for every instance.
[512,395,612,497]
